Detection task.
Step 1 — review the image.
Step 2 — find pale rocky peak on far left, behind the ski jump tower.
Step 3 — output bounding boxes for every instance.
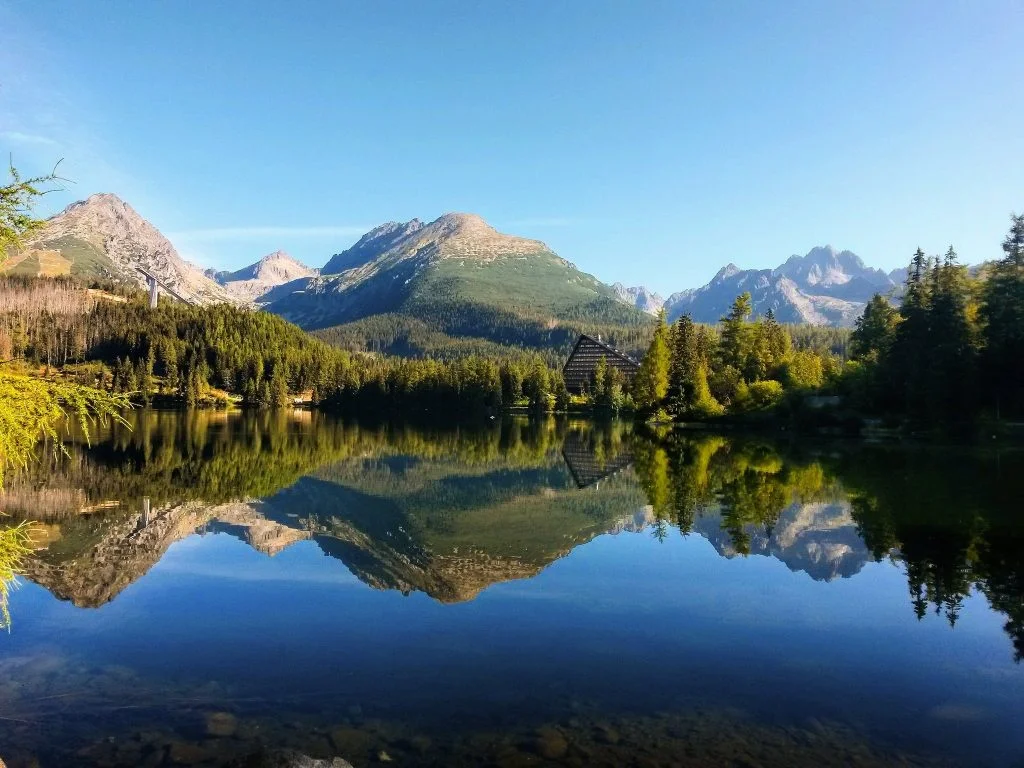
[2,194,236,303]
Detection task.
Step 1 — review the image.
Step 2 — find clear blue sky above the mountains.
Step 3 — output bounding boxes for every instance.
[0,0,1024,293]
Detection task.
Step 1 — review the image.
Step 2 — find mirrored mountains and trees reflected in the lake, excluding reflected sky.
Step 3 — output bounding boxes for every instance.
[0,411,1024,765]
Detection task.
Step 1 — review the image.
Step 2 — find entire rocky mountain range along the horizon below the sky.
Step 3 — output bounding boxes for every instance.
[2,194,902,353]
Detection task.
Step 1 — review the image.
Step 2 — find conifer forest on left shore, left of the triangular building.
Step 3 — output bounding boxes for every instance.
[0,280,568,414]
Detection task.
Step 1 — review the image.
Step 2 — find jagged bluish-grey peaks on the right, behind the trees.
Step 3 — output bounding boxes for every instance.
[666,246,903,327]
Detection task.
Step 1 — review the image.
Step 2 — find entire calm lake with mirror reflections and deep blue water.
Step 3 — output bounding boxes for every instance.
[0,411,1024,768]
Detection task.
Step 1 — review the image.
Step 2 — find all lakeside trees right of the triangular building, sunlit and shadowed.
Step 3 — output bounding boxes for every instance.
[622,215,1024,431]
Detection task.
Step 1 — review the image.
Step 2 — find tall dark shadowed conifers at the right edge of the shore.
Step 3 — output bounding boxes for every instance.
[844,216,1024,426]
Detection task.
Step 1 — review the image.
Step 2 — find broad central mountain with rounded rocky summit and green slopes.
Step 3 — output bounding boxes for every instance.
[267,213,649,354]
